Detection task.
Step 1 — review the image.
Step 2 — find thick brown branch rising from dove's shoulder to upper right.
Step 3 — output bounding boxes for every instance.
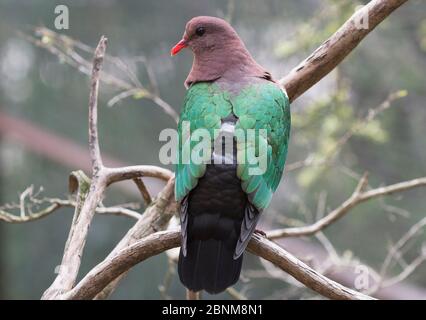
[280,0,407,102]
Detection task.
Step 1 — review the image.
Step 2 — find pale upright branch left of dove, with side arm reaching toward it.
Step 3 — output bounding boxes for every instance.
[42,37,174,299]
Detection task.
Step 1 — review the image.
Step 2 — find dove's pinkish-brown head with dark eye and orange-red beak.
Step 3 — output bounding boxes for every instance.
[171,16,240,56]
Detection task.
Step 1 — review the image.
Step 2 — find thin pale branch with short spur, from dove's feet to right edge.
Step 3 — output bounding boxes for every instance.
[266,175,426,239]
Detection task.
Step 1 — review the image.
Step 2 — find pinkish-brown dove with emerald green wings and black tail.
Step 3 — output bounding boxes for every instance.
[171,16,291,294]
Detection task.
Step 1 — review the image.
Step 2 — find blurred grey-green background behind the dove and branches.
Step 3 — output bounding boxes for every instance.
[0,0,426,299]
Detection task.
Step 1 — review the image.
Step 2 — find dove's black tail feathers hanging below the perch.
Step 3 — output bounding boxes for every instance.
[178,239,243,294]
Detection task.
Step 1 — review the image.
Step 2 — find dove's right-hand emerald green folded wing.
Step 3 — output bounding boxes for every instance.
[232,82,291,211]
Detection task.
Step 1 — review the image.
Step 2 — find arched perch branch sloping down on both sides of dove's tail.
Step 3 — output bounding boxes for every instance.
[64,231,372,300]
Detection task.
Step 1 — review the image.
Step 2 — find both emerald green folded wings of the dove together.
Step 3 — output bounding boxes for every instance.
[175,82,290,211]
